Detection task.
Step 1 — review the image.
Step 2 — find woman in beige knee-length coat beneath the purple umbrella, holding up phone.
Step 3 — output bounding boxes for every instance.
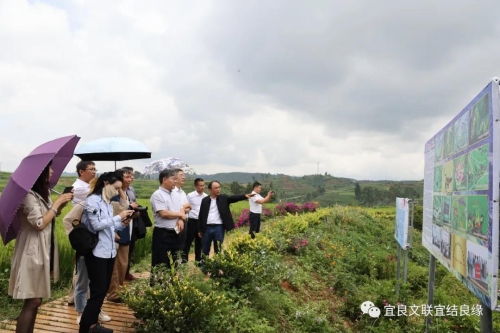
[9,161,73,333]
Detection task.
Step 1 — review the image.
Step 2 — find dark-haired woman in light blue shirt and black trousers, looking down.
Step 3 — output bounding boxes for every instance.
[79,171,134,333]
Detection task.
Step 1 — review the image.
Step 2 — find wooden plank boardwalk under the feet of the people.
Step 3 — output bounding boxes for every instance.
[0,272,149,333]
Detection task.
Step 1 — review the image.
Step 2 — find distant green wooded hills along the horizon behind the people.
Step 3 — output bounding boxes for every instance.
[0,172,423,207]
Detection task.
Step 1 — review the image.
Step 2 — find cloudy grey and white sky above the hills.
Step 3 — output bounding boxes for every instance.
[0,0,500,180]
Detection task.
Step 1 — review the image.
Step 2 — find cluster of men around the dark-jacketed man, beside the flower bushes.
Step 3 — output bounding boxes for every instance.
[150,169,274,272]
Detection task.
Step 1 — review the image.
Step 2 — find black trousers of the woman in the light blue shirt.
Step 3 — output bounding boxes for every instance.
[78,253,115,333]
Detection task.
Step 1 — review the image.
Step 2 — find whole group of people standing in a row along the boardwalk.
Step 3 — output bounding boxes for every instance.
[9,161,273,333]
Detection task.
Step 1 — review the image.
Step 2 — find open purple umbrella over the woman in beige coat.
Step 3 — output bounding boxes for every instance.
[0,135,80,244]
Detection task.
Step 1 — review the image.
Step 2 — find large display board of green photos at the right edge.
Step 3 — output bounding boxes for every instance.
[422,81,500,309]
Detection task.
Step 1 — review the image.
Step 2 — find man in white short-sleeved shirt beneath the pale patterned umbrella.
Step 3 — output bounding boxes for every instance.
[150,169,187,274]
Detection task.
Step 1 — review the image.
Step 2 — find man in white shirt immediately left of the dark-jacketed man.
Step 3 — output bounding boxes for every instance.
[183,178,207,263]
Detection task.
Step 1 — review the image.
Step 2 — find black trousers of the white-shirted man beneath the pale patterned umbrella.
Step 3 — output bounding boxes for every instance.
[151,227,182,268]
